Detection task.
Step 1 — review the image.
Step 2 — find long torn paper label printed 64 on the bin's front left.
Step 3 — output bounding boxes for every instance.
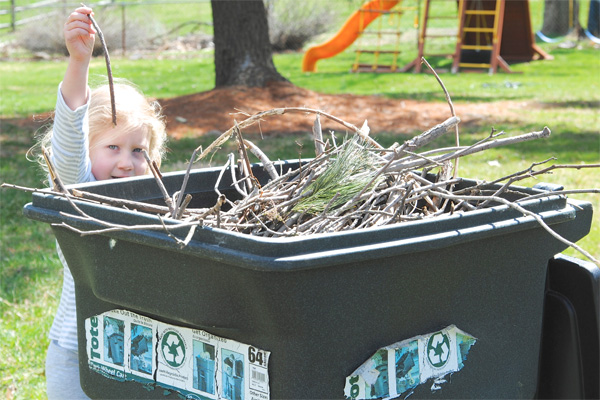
[85,310,270,400]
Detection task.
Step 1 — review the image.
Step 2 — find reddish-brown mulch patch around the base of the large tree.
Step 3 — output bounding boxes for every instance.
[159,83,525,138]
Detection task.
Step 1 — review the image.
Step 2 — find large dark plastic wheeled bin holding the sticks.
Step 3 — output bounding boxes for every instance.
[24,163,592,399]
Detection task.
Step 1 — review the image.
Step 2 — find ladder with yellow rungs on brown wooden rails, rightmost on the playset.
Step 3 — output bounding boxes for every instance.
[452,0,512,74]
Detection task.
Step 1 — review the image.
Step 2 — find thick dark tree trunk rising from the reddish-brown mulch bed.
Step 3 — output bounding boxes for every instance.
[211,0,286,87]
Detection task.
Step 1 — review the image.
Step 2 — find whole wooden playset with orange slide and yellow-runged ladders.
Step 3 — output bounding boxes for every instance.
[302,0,552,73]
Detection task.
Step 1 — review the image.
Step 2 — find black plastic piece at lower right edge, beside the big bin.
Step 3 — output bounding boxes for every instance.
[538,255,600,399]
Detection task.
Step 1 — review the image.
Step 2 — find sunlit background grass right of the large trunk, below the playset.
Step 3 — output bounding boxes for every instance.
[275,45,600,103]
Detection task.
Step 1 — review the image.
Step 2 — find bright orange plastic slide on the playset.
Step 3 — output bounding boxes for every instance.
[302,0,401,72]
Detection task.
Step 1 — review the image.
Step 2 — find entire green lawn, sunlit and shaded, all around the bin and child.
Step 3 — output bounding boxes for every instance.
[0,2,600,399]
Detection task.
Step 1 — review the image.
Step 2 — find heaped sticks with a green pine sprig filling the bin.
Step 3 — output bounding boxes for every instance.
[165,109,550,237]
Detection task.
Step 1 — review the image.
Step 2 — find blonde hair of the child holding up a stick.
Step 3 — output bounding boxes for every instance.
[32,81,167,172]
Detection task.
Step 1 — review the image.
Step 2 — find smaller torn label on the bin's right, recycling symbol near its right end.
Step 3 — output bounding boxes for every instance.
[344,325,477,400]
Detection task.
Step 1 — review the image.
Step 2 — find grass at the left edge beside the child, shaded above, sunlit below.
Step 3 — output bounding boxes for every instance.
[0,122,62,399]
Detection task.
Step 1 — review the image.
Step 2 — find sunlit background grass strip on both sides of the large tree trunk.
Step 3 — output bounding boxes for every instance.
[0,46,600,117]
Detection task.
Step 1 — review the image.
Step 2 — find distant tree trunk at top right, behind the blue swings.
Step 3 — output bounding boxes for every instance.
[542,0,581,37]
